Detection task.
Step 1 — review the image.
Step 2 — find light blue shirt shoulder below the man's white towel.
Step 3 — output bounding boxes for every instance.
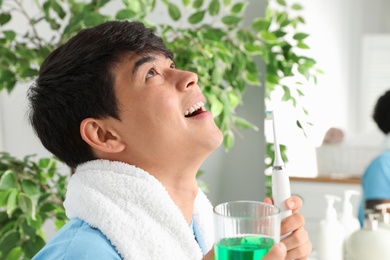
[33,219,122,260]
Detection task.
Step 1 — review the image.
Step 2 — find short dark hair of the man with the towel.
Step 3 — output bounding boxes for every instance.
[28,21,173,167]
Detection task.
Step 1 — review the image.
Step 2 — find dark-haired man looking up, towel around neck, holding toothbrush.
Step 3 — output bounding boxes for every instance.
[29,21,311,259]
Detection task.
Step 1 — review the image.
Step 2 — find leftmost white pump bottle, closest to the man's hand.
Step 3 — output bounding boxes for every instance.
[318,194,345,260]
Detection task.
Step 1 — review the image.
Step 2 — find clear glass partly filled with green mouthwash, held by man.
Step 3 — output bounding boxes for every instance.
[214,201,280,260]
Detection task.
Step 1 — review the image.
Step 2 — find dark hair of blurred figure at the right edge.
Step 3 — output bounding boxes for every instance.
[372,90,390,134]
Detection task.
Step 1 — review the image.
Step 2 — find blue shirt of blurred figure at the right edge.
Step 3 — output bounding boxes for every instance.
[358,150,390,226]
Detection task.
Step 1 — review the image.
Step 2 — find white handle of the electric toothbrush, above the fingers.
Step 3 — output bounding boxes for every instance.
[272,170,292,220]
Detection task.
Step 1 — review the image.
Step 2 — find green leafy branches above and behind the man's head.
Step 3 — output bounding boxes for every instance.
[0,0,316,256]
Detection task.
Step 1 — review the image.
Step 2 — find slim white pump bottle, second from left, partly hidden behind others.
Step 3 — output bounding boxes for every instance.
[340,190,360,259]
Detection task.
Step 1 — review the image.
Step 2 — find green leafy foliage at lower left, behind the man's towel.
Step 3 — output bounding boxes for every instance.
[0,153,68,259]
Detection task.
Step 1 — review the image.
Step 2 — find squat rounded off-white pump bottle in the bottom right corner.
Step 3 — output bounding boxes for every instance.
[346,213,390,260]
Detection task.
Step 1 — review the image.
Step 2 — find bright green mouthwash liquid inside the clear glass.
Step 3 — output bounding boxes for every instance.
[214,236,274,260]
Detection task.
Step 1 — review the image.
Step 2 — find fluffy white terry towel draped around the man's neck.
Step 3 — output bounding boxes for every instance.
[64,160,213,260]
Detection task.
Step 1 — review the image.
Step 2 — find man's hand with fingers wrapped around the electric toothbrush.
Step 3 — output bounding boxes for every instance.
[264,196,312,259]
